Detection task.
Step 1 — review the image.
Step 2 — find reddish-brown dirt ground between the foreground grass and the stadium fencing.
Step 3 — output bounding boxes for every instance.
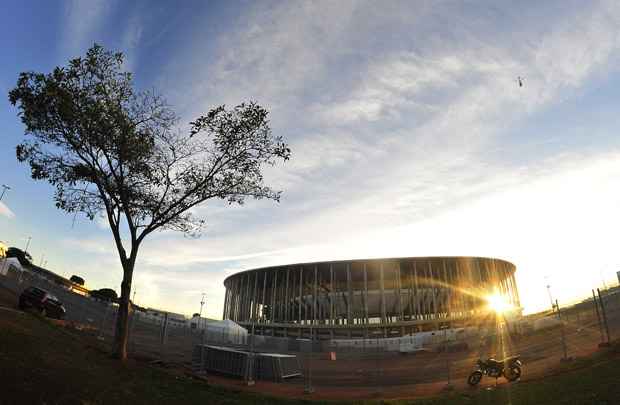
[195,304,620,399]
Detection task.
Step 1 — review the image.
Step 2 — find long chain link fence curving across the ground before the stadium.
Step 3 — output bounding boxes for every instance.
[0,266,620,396]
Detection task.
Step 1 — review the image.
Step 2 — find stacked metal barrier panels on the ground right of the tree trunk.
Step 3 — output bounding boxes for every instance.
[192,345,301,382]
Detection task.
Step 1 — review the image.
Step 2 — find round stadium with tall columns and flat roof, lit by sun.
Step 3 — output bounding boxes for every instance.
[224,257,520,339]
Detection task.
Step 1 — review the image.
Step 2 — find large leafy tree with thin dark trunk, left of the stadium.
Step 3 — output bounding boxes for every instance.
[9,44,291,359]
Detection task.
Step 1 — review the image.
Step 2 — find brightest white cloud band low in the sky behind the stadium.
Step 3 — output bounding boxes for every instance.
[58,147,620,317]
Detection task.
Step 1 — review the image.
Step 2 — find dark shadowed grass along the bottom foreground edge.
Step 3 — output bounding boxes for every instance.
[0,309,620,405]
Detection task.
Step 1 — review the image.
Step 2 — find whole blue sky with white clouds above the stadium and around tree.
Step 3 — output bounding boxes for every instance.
[0,0,620,318]
